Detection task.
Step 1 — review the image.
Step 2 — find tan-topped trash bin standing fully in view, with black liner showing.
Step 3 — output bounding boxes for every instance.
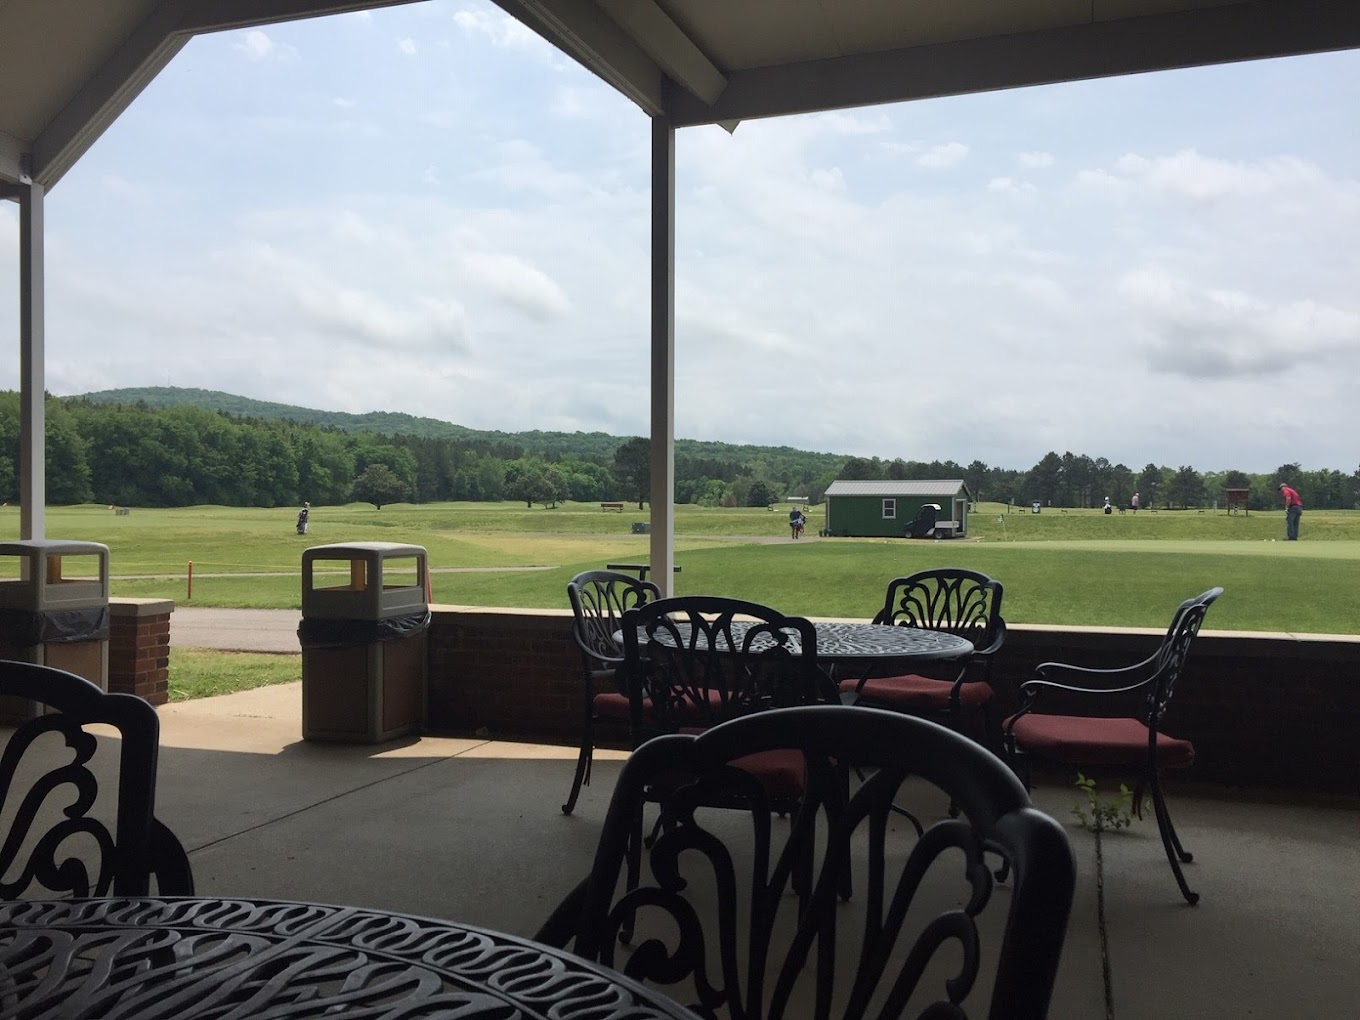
[298,541,430,743]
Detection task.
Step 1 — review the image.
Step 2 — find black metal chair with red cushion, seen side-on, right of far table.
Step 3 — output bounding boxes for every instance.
[1004,588,1223,906]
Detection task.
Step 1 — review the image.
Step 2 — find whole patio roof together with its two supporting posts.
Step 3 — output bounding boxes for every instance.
[0,0,1360,583]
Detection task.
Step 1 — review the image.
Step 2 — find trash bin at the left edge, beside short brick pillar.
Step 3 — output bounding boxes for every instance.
[0,539,109,719]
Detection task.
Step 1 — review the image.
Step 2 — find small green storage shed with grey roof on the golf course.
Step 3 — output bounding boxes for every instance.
[826,479,972,539]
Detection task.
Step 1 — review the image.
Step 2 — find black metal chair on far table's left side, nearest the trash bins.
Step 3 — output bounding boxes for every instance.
[562,570,661,815]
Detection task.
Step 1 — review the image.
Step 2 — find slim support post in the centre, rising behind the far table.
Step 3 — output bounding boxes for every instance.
[651,117,676,596]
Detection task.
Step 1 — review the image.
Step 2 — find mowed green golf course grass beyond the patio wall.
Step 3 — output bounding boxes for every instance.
[10,503,1360,634]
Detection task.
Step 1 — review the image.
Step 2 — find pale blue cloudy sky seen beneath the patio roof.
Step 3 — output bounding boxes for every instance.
[0,0,1360,472]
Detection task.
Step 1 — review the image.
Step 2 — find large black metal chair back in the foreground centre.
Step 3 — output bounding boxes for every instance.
[537,706,1076,1020]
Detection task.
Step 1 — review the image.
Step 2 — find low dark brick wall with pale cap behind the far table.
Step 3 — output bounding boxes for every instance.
[430,607,1360,794]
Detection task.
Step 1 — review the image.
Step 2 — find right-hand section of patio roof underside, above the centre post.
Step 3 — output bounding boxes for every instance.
[495,0,1360,128]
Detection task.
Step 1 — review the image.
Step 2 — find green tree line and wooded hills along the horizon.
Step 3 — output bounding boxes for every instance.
[0,390,1360,510]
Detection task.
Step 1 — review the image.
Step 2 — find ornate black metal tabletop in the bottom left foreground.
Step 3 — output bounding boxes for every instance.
[0,898,694,1020]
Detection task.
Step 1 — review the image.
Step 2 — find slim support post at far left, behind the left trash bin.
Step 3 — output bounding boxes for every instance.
[19,184,48,539]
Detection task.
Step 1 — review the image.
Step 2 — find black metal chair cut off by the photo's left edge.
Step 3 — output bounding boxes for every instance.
[0,661,193,899]
